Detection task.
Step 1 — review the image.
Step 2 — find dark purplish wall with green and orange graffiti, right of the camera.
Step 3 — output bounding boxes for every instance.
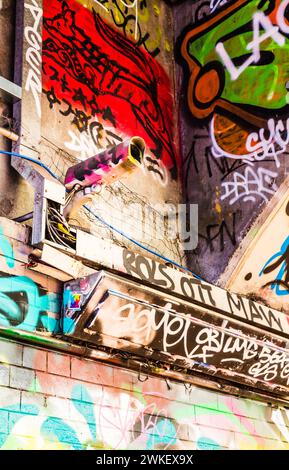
[175,0,289,281]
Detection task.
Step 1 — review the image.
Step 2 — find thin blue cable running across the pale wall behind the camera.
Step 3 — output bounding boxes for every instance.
[0,150,206,282]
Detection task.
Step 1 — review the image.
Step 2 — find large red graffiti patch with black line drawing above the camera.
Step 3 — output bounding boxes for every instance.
[43,0,178,178]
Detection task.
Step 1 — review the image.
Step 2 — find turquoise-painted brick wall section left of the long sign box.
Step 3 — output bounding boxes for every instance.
[0,218,62,334]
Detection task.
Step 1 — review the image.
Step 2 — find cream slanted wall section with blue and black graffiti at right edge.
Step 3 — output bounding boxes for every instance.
[227,185,289,314]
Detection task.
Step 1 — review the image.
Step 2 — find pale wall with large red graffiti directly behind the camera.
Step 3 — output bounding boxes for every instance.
[15,0,181,260]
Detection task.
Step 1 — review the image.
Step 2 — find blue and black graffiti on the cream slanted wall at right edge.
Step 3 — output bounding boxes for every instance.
[259,237,289,295]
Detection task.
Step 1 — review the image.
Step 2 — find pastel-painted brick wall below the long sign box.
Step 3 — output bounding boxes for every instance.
[0,340,289,449]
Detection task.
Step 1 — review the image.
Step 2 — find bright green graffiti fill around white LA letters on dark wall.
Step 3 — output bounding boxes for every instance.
[183,0,289,110]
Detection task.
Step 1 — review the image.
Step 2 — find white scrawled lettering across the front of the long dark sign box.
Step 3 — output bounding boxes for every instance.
[96,302,289,385]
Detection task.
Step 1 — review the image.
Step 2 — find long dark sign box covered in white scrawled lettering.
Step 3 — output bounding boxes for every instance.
[62,271,289,395]
